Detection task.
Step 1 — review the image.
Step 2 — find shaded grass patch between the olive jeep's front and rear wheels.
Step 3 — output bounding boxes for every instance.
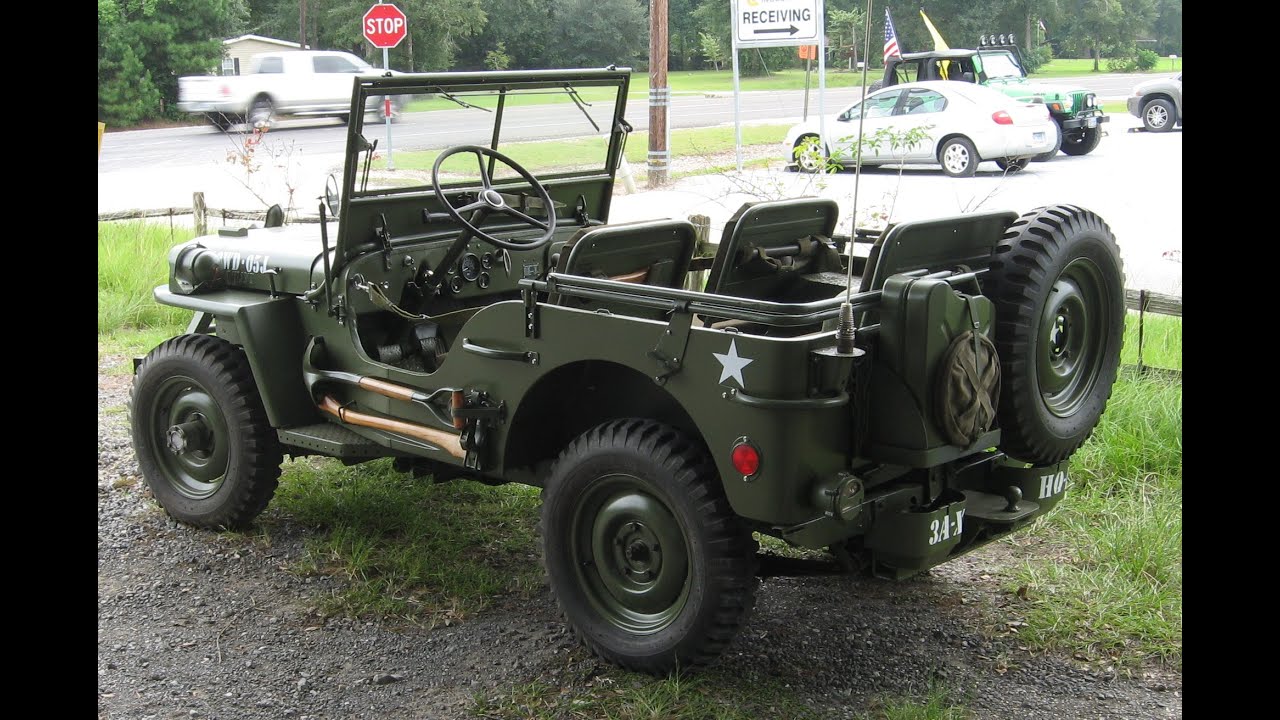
[272,460,543,625]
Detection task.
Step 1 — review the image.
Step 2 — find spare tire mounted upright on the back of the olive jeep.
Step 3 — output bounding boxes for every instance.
[983,205,1125,465]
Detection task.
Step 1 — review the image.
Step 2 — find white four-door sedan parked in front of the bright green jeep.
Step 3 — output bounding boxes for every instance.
[783,81,1059,177]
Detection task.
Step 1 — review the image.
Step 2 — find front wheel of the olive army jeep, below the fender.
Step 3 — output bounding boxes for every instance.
[129,334,283,528]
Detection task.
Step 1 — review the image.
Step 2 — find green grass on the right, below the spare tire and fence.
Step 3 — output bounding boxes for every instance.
[1014,315,1183,666]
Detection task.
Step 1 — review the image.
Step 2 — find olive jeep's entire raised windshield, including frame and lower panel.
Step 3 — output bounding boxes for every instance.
[334,68,631,270]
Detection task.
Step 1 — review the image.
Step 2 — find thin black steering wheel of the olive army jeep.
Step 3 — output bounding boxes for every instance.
[431,145,556,250]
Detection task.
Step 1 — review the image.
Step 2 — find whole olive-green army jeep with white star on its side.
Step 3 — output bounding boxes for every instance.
[131,68,1125,673]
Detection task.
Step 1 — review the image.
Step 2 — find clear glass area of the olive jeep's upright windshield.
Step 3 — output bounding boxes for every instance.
[348,76,626,196]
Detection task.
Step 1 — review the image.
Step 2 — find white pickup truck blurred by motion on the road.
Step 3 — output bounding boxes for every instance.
[178,50,398,131]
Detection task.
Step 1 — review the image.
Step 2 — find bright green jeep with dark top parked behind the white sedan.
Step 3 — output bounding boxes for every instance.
[872,35,1110,160]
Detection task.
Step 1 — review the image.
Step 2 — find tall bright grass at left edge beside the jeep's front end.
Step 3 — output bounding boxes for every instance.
[97,222,195,336]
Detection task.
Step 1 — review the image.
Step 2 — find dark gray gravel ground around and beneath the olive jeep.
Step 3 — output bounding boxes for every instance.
[97,357,1183,720]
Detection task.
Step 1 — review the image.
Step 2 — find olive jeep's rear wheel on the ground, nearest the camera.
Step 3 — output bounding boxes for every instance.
[541,419,755,674]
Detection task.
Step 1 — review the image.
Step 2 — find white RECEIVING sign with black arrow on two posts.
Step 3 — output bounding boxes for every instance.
[730,0,827,172]
